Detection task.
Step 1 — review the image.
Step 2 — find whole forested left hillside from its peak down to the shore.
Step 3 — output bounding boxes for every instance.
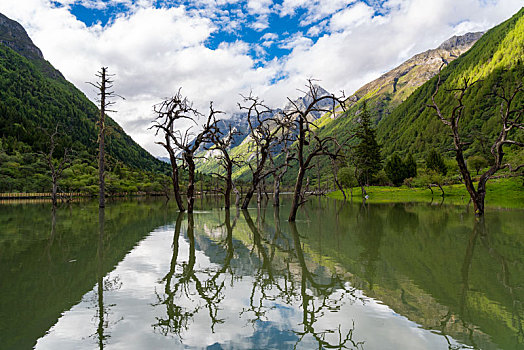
[0,15,168,191]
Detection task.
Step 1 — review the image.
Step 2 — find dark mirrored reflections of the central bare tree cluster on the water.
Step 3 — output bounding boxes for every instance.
[153,207,366,349]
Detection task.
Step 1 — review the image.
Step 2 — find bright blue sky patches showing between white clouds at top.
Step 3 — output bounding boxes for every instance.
[65,0,376,60]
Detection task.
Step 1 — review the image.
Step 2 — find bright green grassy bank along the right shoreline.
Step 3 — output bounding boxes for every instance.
[329,177,524,209]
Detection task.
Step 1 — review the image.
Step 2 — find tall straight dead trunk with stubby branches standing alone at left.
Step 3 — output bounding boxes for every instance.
[88,67,123,208]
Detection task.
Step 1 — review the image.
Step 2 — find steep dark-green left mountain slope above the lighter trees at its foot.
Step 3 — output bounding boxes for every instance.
[0,14,168,171]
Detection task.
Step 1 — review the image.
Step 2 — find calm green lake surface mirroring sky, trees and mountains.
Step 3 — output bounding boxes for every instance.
[0,199,524,349]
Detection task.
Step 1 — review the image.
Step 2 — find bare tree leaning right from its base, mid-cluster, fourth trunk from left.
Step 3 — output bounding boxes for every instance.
[239,95,282,209]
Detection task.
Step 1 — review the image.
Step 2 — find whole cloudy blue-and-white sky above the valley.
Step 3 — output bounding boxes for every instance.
[0,0,523,156]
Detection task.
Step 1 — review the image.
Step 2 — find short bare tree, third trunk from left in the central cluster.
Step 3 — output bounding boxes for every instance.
[210,125,240,209]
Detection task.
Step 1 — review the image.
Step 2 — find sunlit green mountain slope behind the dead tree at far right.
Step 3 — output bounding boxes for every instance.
[377,9,524,156]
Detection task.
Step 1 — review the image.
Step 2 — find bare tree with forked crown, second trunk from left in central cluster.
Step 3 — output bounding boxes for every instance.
[152,90,221,213]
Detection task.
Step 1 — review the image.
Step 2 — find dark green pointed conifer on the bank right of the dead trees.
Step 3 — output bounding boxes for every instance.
[354,103,382,185]
